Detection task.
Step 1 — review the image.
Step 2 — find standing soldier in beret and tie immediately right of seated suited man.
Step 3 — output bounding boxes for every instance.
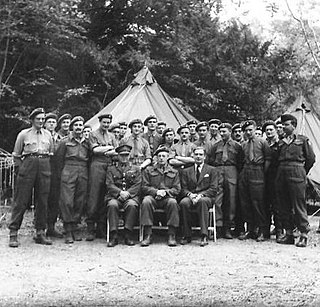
[207,123,243,239]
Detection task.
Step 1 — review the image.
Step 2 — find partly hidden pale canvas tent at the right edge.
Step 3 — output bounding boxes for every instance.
[286,96,320,196]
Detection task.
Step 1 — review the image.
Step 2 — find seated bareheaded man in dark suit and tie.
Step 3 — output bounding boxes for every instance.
[180,147,219,246]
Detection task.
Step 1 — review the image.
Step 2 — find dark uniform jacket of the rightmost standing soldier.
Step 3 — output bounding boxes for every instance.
[279,134,315,173]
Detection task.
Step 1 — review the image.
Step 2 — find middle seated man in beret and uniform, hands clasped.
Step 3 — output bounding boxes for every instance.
[140,147,181,246]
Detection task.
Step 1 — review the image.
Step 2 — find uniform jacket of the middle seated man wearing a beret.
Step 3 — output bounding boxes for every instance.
[142,164,181,197]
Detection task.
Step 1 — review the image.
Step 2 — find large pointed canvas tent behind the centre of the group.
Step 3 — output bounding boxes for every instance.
[87,67,198,129]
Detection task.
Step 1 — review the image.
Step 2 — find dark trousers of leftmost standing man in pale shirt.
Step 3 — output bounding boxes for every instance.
[9,156,51,230]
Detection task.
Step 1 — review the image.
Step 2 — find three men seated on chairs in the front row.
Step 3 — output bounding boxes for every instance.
[106,145,218,247]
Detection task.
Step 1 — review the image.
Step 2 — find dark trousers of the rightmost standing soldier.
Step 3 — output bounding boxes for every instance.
[276,162,310,233]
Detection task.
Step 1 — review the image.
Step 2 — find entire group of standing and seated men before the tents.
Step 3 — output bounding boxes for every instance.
[9,108,315,247]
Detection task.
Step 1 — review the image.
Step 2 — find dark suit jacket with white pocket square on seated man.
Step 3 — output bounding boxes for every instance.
[181,163,219,198]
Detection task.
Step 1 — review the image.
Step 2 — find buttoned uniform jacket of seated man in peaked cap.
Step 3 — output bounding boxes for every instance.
[106,164,142,202]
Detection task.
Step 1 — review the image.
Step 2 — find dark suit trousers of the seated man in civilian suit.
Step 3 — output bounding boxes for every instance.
[180,197,212,237]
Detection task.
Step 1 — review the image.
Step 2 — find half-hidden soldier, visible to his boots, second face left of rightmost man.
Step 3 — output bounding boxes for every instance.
[262,120,283,240]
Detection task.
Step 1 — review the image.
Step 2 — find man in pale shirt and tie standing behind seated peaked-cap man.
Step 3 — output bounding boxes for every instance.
[120,118,152,169]
